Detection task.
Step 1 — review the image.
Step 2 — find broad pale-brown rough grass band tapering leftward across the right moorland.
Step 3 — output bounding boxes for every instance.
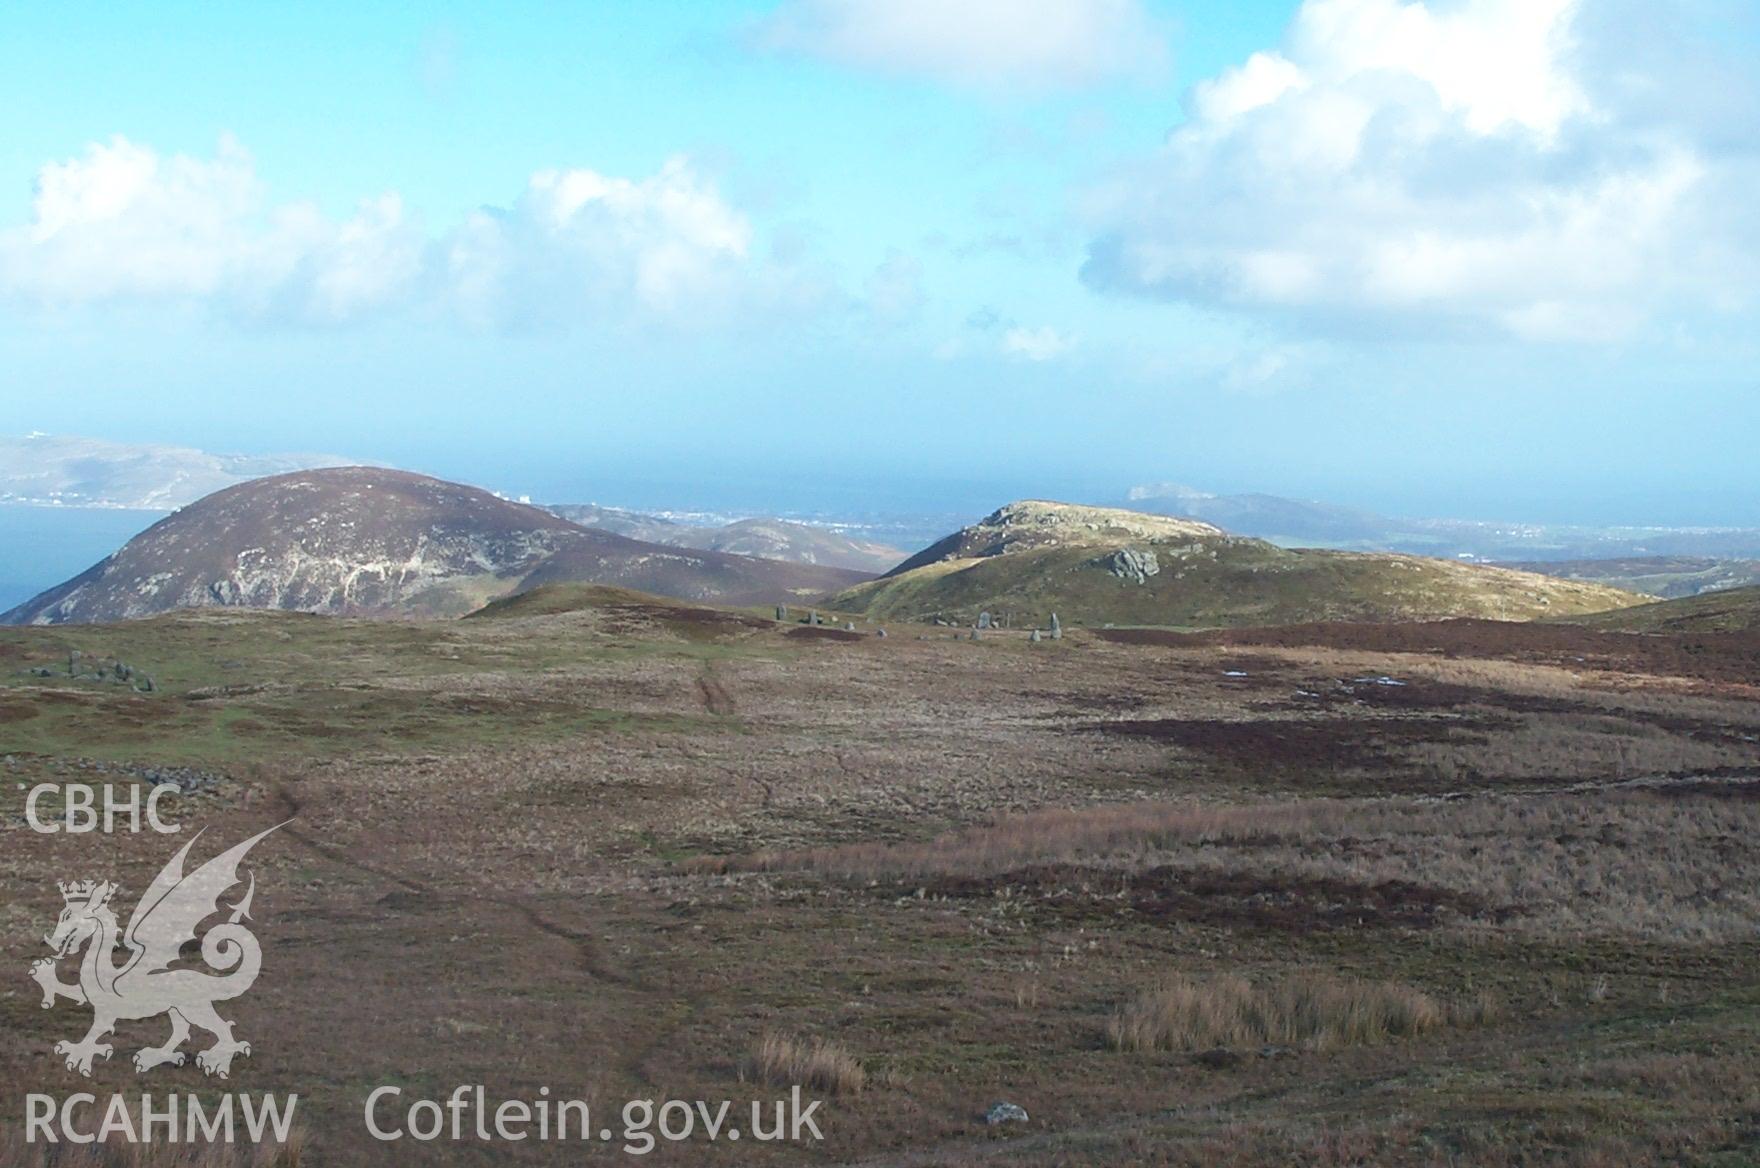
[685,790,1760,941]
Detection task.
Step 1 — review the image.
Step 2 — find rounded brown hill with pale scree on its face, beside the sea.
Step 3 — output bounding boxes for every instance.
[0,466,866,624]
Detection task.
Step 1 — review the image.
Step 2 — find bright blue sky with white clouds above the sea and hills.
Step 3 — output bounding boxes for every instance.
[0,0,1760,524]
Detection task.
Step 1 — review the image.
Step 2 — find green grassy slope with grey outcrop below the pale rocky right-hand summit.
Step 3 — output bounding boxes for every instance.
[831,520,1642,626]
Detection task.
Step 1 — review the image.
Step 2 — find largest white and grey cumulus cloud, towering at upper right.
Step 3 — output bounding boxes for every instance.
[1082,0,1756,339]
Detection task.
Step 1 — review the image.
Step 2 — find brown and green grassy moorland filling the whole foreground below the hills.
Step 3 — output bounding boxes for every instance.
[0,591,1760,1168]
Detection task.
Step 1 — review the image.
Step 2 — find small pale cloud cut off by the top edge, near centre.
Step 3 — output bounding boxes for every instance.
[759,0,1165,90]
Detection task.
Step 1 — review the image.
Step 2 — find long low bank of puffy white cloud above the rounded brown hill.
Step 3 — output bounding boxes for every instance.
[0,137,770,324]
